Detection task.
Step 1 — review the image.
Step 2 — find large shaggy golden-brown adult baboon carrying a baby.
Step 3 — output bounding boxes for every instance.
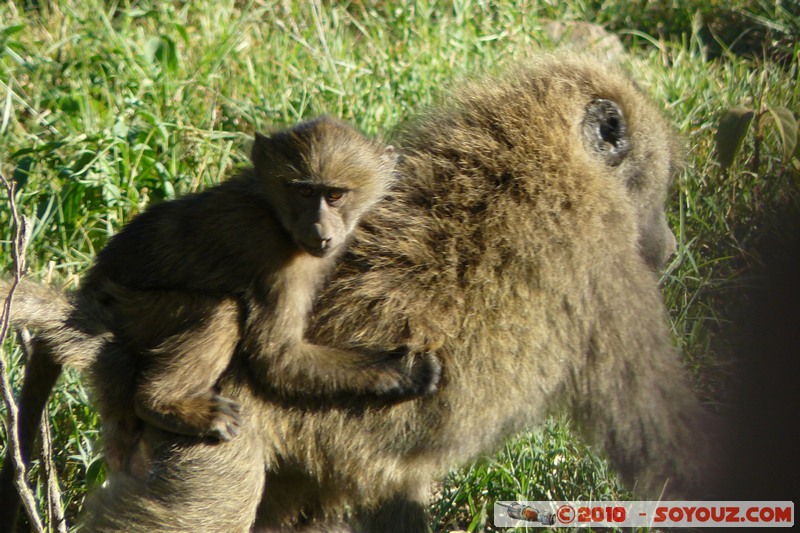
[0,57,711,532]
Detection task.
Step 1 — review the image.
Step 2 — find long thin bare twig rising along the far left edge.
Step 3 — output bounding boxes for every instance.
[0,173,44,533]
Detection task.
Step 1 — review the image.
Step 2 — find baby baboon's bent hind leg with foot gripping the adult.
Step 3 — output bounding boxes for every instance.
[136,298,240,440]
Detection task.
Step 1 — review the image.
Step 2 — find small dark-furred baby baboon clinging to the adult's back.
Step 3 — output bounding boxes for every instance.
[2,117,439,528]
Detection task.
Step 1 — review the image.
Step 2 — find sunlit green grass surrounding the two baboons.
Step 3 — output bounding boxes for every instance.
[0,0,800,530]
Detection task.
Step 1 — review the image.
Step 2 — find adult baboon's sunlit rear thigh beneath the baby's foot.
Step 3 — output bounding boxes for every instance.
[81,422,266,533]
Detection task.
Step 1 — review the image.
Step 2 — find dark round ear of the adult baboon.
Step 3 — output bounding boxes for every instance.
[583,98,631,167]
